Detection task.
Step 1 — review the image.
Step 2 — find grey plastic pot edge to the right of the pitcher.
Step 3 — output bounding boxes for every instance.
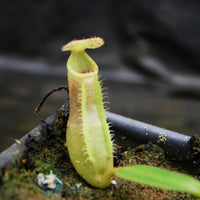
[106,112,191,160]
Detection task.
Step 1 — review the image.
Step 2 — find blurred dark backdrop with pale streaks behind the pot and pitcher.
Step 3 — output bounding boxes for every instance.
[0,0,200,151]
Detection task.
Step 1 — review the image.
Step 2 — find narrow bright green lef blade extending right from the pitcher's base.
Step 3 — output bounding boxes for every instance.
[115,165,200,197]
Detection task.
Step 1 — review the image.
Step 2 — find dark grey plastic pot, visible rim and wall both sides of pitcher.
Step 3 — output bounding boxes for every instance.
[0,109,191,170]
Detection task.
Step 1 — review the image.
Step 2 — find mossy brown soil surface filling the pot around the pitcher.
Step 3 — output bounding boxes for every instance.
[0,111,199,200]
